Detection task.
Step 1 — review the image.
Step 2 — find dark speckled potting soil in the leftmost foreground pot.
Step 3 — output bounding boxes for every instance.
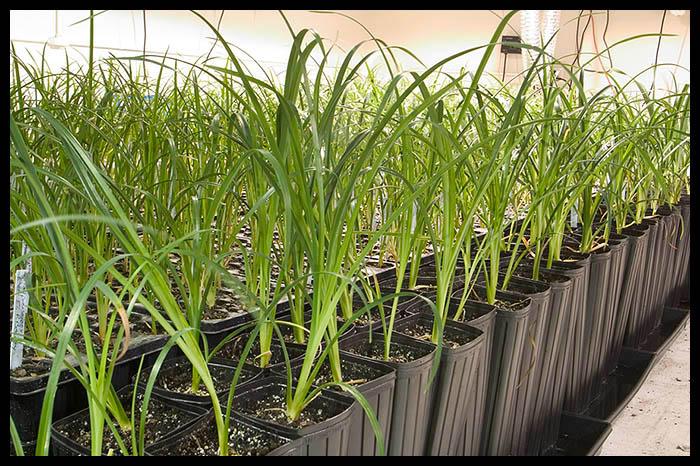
[58,392,198,455]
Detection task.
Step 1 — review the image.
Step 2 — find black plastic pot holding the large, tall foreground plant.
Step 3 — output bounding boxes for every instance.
[232,375,360,456]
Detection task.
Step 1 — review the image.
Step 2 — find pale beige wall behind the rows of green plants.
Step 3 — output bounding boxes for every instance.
[10,10,690,92]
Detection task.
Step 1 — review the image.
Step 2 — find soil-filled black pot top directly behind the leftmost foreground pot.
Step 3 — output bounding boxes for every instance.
[134,356,263,409]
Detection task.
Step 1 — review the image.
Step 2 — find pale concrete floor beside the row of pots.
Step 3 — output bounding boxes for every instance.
[600,321,690,456]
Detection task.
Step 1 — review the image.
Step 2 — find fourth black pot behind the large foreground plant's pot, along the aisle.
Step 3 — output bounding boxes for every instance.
[474,284,532,456]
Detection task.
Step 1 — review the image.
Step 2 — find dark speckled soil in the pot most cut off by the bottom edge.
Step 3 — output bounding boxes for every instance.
[148,418,287,456]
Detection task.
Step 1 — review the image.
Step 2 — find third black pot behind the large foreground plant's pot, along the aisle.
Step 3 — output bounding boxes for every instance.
[394,313,485,456]
